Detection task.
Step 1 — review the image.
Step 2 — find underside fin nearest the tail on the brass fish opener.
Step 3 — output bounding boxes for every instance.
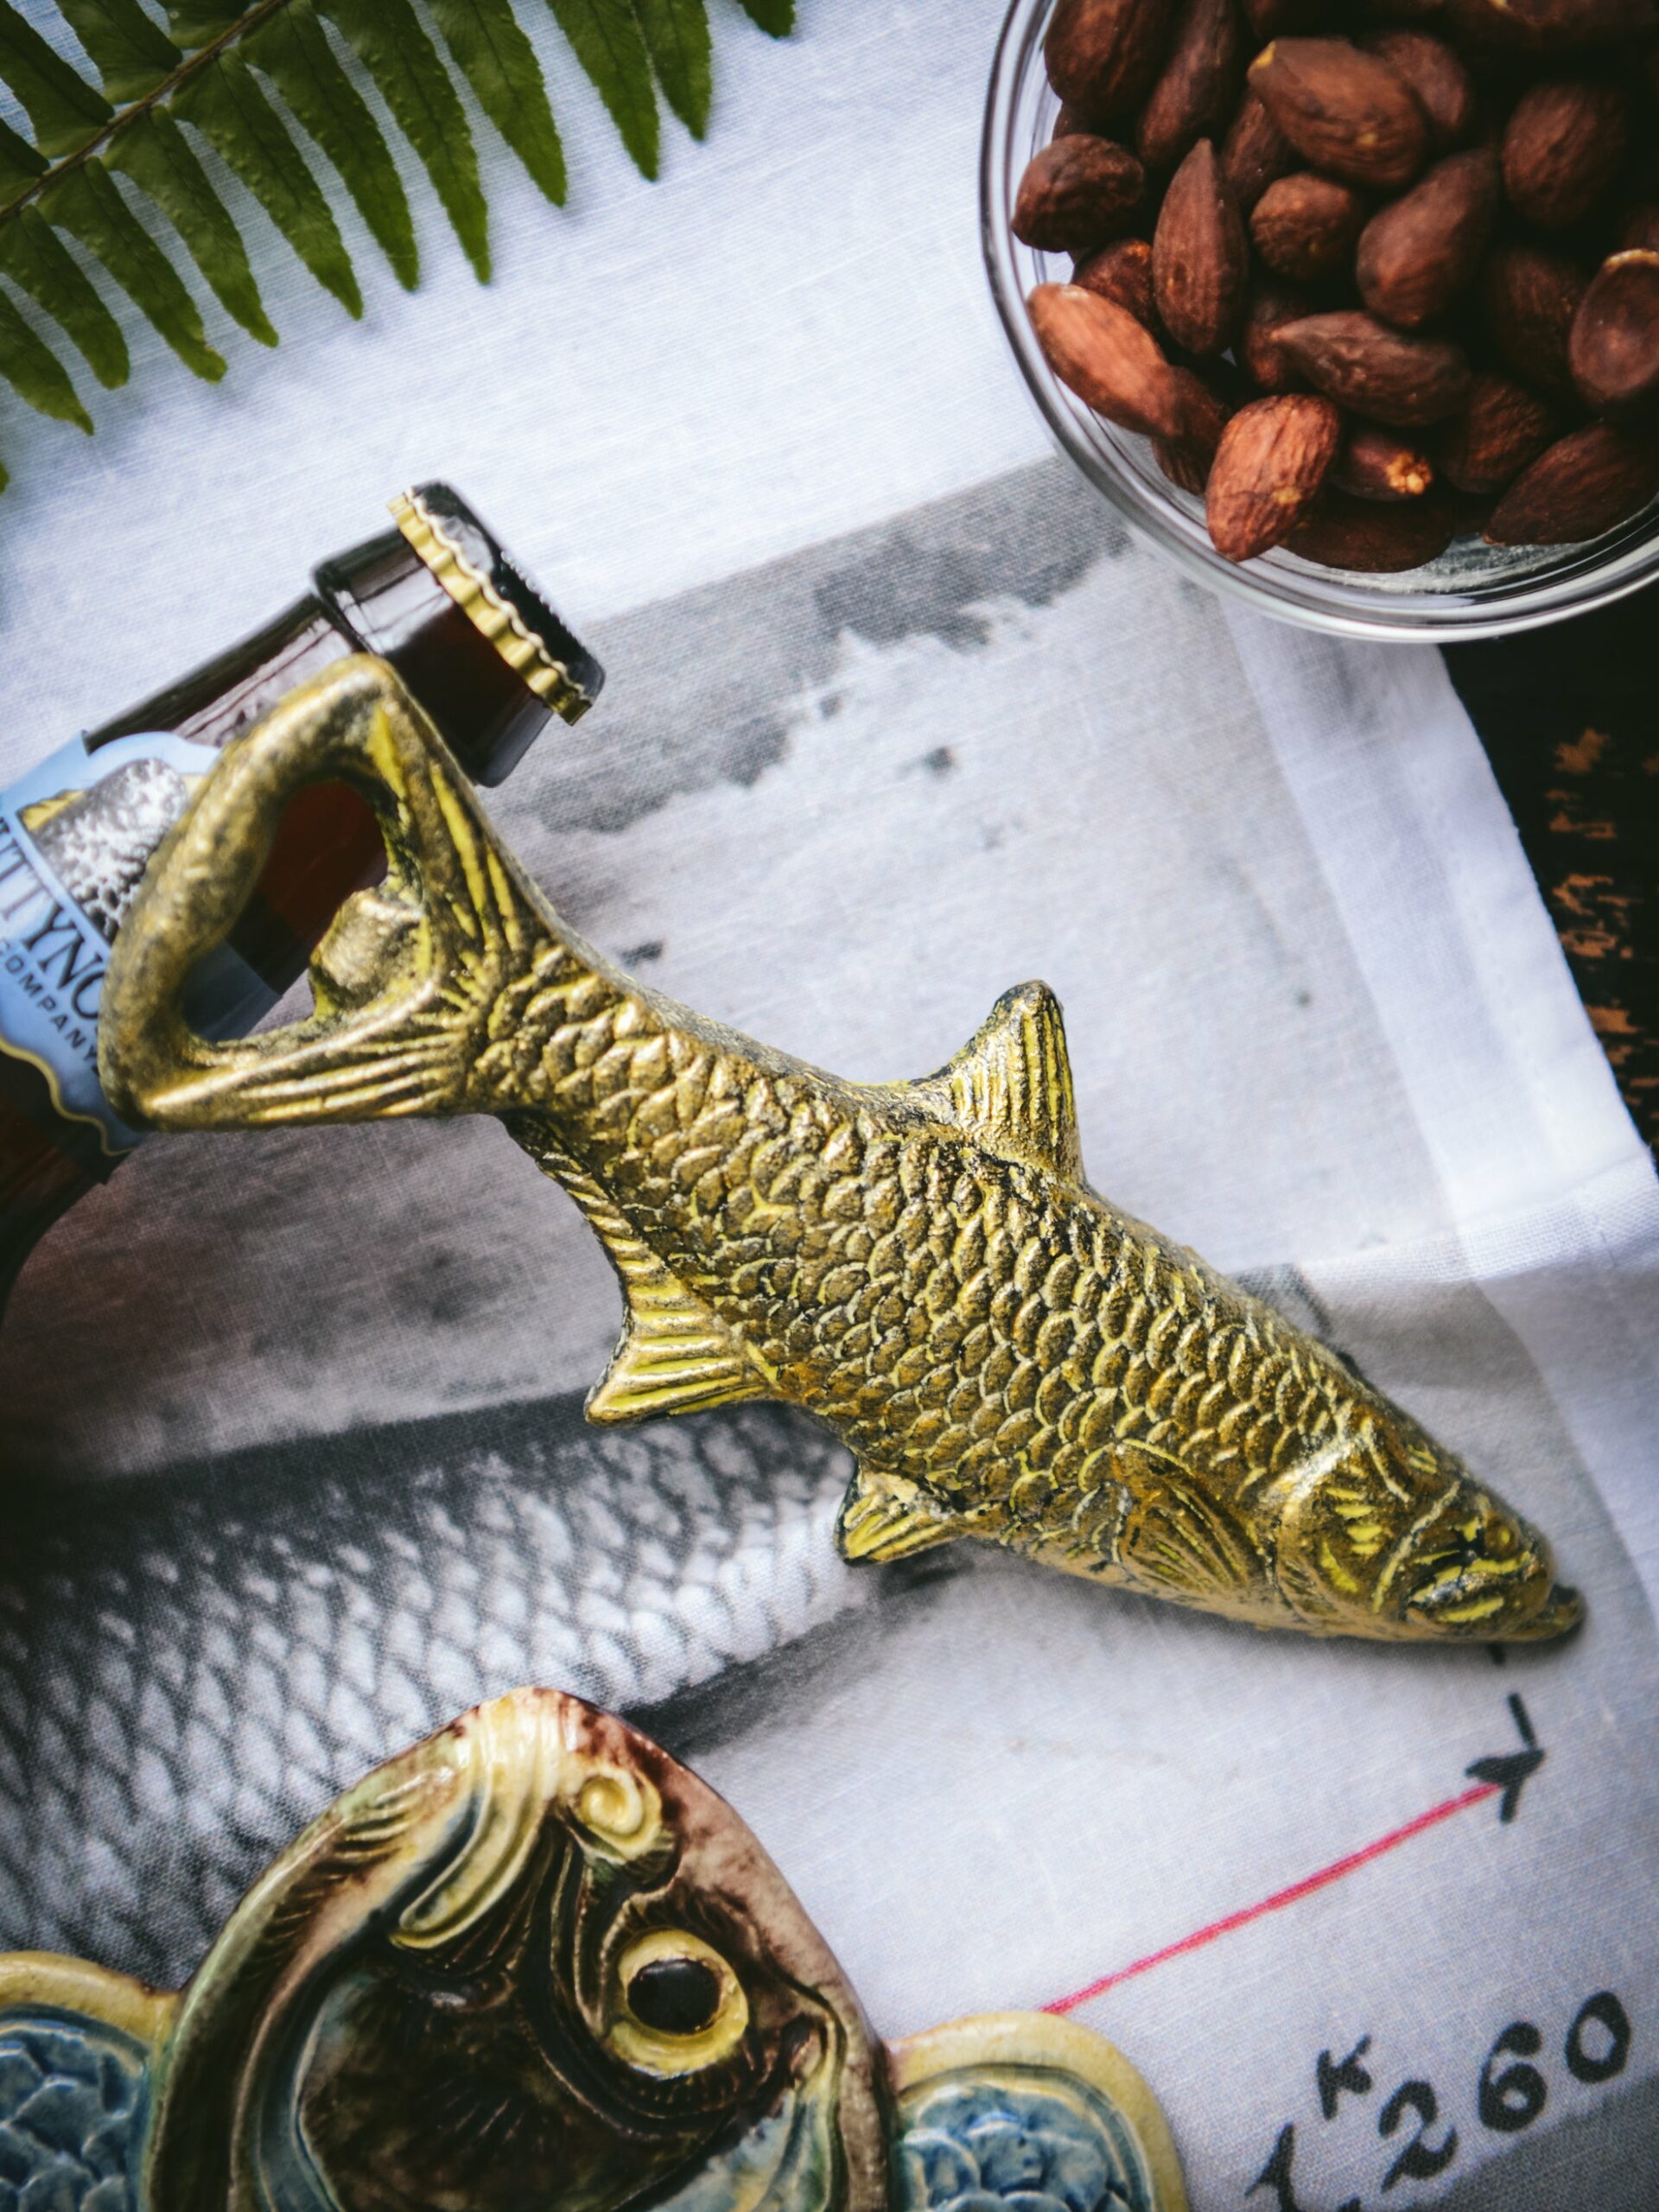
[509,1119,770,1427]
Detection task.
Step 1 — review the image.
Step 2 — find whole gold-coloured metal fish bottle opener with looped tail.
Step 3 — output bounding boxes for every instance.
[102,659,1581,1642]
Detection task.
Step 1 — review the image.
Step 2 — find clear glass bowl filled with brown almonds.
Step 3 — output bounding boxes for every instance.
[980,0,1659,641]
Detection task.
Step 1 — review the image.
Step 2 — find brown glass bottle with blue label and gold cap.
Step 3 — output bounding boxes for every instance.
[0,485,604,1307]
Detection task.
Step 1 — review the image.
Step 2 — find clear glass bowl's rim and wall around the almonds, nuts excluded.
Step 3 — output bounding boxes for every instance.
[980,0,1659,644]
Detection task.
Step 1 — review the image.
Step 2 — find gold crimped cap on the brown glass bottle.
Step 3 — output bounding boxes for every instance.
[391,485,604,721]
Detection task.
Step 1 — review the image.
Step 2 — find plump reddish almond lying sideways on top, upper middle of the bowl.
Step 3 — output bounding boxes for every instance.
[1249,38,1429,193]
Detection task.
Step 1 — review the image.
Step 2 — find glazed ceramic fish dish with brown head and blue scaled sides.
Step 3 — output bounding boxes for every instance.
[0,1690,1185,2212]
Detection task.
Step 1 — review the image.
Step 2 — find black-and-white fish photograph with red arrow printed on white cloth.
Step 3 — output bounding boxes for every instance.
[0,462,1659,2212]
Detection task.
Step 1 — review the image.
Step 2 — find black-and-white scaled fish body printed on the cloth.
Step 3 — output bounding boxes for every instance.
[0,1400,858,1991]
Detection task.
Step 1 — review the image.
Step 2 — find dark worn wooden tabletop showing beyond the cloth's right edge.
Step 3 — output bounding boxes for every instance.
[1446,586,1659,1146]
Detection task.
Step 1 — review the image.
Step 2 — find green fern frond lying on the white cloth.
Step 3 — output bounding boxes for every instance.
[0,0,814,491]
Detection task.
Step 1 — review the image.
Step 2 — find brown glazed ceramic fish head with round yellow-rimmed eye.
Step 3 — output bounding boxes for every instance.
[146,1690,885,2212]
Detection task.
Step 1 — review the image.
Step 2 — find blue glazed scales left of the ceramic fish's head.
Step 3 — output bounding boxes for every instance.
[0,2022,142,2212]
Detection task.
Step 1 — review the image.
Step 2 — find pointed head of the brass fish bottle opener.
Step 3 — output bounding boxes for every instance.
[1274,1398,1584,1643]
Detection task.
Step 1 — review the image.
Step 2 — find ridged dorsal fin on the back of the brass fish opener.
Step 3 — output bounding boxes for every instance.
[916,982,1084,1181]
